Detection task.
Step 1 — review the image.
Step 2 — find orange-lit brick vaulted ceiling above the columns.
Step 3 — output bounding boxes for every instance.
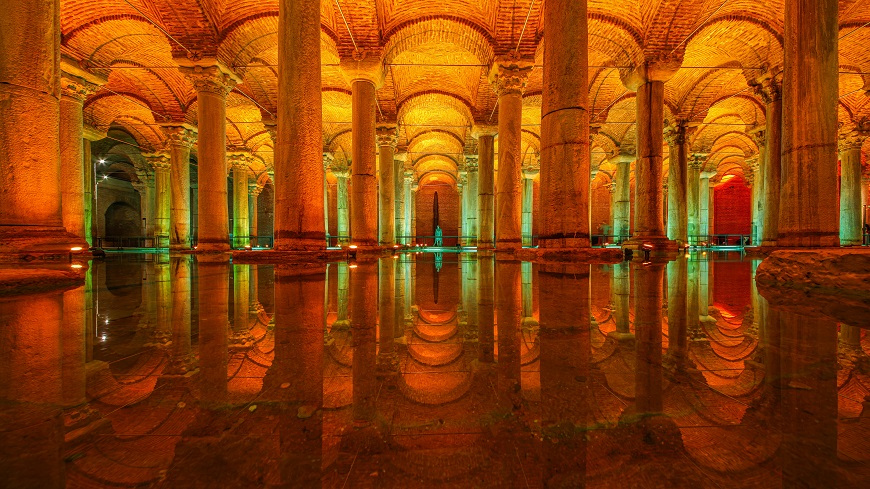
[61,0,870,183]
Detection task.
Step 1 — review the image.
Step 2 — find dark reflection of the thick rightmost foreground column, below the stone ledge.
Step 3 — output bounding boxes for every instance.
[771,308,840,487]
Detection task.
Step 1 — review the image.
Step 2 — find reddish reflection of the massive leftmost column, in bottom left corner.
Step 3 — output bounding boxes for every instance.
[0,284,67,487]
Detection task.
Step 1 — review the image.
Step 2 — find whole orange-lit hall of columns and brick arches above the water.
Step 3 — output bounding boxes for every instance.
[0,0,870,254]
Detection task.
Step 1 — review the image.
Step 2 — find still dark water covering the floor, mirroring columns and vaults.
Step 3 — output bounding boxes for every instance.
[0,254,870,488]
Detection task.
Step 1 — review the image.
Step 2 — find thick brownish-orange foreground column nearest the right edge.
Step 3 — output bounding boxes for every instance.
[776,0,840,247]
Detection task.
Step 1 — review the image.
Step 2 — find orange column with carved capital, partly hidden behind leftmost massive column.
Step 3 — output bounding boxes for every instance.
[59,67,106,239]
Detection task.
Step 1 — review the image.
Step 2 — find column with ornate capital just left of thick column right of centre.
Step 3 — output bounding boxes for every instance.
[489,59,532,249]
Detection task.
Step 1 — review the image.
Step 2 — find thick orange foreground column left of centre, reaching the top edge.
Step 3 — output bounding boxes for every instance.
[273,0,324,250]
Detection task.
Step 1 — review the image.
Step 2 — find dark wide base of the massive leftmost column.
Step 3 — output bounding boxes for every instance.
[0,226,88,261]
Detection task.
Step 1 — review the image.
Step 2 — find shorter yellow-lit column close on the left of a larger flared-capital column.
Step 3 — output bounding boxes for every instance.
[163,124,196,250]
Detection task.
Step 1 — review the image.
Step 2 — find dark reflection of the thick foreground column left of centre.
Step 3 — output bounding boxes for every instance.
[272,264,326,487]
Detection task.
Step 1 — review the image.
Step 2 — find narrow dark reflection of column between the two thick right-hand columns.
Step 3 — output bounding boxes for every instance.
[633,262,665,413]
